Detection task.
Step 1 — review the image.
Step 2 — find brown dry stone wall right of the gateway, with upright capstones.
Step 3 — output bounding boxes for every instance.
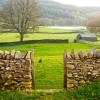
[64,49,100,88]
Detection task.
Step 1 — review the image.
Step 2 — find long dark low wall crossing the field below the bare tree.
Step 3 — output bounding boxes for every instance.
[0,39,69,47]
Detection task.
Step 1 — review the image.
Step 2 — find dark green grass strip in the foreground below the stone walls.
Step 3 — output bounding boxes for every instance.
[0,81,100,100]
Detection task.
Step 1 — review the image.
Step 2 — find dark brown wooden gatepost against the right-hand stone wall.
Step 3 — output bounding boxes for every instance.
[64,50,67,90]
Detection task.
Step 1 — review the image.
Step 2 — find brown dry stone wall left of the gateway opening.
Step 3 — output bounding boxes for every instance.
[0,51,34,91]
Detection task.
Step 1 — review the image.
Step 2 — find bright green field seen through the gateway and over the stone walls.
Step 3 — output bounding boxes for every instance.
[0,43,100,89]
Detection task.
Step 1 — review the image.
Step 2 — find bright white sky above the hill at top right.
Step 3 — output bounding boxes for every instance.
[54,0,100,7]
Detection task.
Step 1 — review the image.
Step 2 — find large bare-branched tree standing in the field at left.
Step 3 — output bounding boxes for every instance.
[1,0,38,41]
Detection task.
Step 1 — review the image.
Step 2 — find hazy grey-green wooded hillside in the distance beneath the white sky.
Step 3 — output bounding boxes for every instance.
[0,0,100,25]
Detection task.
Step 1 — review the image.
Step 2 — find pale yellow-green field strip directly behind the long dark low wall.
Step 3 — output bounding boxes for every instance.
[0,33,77,42]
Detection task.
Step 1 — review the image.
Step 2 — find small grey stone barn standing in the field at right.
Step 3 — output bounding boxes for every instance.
[76,33,97,42]
